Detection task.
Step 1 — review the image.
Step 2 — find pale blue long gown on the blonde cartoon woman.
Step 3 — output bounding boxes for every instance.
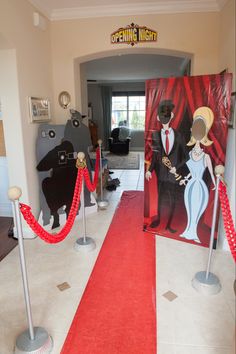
[180,151,209,242]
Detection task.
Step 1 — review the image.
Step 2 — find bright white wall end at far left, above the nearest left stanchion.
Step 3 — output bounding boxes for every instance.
[0,49,29,203]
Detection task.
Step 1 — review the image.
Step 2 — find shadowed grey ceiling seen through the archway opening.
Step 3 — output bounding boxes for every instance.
[81,54,189,83]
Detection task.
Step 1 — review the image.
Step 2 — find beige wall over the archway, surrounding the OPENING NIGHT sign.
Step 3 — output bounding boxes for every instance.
[51,12,219,123]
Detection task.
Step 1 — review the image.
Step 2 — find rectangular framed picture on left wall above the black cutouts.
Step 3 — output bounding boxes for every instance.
[29,97,51,123]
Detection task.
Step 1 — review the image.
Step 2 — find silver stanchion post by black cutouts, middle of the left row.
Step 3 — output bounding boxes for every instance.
[74,152,96,252]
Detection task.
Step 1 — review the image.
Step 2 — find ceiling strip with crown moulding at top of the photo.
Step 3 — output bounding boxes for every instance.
[28,0,228,20]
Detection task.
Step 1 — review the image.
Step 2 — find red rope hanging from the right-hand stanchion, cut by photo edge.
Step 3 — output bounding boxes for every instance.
[219,181,236,261]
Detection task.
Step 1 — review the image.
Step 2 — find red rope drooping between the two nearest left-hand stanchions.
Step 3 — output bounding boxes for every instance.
[20,168,84,243]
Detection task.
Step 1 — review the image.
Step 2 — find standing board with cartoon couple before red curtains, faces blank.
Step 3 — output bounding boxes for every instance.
[144,74,232,246]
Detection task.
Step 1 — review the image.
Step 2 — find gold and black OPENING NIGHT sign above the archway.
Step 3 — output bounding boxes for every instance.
[111,23,157,46]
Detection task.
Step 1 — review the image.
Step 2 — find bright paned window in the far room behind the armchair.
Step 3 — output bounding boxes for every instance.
[111,92,145,130]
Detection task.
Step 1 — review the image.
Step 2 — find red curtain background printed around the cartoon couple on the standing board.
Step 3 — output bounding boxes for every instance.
[144,74,232,246]
